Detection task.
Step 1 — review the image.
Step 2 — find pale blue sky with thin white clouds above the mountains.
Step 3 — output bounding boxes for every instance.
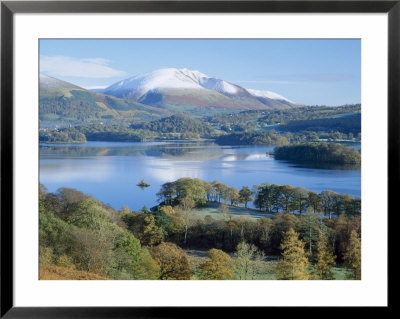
[40,39,361,105]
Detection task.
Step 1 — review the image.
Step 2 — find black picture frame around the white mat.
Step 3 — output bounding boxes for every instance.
[0,0,394,318]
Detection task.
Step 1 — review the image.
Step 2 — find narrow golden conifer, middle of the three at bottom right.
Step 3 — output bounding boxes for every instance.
[316,230,335,280]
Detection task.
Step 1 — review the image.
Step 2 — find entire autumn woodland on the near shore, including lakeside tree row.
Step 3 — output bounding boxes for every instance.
[39,178,361,280]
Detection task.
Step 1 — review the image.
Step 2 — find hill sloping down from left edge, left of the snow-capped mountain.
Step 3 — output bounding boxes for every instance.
[39,75,171,128]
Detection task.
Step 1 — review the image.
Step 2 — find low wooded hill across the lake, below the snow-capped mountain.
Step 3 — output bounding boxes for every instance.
[131,114,214,137]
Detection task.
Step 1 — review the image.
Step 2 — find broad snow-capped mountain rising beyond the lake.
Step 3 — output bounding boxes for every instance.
[103,68,295,111]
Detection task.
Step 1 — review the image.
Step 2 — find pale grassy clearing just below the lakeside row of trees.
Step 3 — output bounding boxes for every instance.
[192,202,274,220]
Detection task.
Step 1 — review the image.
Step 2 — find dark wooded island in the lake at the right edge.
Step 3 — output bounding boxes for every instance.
[274,143,361,165]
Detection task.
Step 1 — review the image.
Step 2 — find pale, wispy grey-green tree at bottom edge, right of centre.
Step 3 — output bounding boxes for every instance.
[234,241,264,280]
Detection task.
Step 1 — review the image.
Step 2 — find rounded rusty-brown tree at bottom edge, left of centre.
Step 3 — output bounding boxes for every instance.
[150,243,192,280]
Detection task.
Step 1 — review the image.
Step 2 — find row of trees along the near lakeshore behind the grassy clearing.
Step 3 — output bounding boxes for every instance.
[157,177,361,219]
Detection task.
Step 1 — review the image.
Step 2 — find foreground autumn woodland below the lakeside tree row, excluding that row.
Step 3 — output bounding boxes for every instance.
[39,186,361,279]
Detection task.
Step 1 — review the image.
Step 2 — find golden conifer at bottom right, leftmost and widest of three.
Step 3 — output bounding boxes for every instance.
[276,228,310,280]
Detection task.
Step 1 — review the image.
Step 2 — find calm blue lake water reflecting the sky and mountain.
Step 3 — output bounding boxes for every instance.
[40,142,361,210]
